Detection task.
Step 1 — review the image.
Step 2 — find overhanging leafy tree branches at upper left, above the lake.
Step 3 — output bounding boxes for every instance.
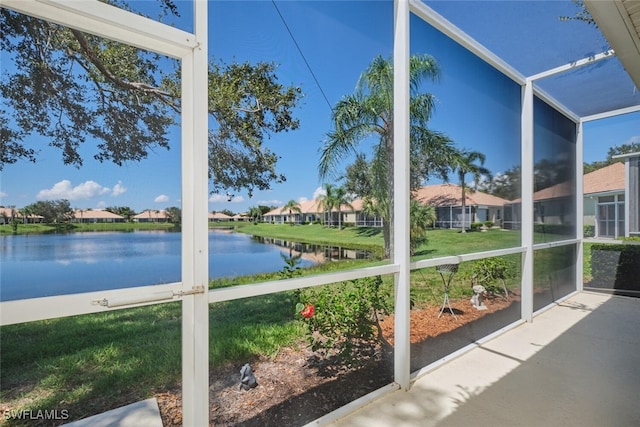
[0,0,301,194]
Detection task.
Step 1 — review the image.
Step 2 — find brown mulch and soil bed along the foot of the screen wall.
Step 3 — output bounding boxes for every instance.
[156,296,519,427]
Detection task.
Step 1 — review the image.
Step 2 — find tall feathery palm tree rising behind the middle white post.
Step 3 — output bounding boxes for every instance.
[318,51,450,256]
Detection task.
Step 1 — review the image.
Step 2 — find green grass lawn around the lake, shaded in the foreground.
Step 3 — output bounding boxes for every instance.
[0,224,588,425]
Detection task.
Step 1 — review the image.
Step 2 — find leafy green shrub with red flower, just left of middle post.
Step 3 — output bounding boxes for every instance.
[296,276,390,366]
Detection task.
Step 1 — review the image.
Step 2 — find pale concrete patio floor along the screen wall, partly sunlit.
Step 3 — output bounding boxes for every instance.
[331,292,640,427]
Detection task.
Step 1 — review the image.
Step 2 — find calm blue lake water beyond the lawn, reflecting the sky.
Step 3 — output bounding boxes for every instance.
[0,230,344,301]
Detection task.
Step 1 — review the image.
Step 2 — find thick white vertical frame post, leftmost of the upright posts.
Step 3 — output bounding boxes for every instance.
[181,0,209,426]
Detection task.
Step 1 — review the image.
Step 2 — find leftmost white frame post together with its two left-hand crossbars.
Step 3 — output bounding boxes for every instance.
[0,0,209,426]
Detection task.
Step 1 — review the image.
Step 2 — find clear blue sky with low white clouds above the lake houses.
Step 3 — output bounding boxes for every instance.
[0,1,640,212]
